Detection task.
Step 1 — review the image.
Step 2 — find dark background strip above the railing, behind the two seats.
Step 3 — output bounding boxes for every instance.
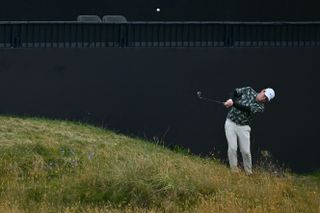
[0,0,320,21]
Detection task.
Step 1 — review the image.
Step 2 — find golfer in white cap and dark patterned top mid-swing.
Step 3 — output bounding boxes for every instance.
[224,87,275,175]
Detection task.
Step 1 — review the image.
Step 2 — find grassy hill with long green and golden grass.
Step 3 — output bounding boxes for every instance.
[0,116,320,213]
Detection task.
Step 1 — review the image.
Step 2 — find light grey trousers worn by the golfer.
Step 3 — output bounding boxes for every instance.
[224,119,252,174]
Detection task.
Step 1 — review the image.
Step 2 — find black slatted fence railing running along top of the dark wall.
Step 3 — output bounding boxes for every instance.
[0,22,320,48]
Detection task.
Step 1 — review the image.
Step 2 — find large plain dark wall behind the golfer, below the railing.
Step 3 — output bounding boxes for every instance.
[0,48,320,172]
